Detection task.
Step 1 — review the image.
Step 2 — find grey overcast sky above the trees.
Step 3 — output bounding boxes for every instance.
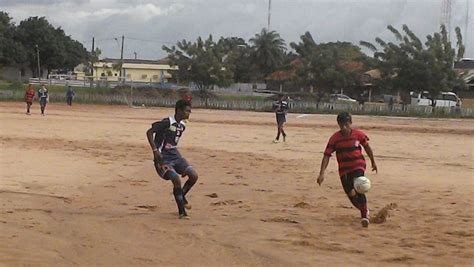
[0,0,474,59]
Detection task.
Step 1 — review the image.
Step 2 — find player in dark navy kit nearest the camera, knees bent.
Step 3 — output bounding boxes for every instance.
[146,99,198,219]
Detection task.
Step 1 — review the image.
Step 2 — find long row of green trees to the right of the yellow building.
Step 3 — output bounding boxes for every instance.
[163,25,466,98]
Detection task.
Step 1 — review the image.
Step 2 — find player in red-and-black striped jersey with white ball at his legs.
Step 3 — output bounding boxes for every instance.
[317,112,377,227]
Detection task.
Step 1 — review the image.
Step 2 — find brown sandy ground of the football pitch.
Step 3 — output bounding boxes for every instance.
[0,102,474,266]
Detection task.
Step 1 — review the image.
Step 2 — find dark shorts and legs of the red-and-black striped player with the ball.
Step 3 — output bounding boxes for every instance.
[341,171,369,227]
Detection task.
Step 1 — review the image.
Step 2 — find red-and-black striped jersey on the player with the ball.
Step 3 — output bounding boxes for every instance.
[324,129,369,176]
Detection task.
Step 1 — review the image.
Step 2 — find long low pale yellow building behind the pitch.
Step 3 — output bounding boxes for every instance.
[93,58,177,82]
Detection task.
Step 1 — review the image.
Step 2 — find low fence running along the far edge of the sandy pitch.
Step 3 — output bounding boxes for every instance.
[0,90,474,118]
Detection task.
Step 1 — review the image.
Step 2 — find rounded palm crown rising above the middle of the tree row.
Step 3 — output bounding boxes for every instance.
[250,28,286,78]
